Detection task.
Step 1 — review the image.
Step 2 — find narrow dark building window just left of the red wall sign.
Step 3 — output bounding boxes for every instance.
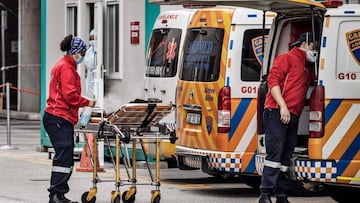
[104,3,120,78]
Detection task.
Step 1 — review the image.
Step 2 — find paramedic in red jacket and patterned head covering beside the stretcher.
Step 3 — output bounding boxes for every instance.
[43,35,95,203]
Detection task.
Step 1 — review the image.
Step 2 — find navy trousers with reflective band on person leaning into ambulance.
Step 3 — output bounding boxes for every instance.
[260,109,299,197]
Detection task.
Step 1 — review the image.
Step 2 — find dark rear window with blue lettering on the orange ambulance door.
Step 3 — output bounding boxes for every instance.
[180,28,224,82]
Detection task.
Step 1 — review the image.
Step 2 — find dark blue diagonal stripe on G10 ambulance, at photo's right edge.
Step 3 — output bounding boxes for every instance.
[337,133,360,175]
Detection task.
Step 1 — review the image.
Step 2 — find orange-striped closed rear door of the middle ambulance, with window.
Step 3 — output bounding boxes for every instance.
[176,7,234,150]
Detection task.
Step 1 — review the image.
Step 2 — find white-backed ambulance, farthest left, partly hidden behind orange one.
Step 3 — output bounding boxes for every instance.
[143,8,196,163]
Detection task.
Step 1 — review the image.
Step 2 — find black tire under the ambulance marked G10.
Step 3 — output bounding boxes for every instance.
[325,185,360,203]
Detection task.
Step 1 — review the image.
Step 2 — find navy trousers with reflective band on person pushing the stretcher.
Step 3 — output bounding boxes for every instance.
[43,112,74,195]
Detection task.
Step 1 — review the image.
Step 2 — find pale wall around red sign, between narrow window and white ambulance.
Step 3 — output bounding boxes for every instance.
[104,0,146,111]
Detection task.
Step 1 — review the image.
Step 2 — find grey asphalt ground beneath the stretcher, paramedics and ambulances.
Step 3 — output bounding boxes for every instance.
[0,115,334,203]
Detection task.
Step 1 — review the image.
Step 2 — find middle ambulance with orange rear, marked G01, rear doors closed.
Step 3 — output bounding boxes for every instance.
[169,7,274,181]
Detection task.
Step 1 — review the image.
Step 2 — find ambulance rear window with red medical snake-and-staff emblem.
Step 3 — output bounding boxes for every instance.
[145,28,181,77]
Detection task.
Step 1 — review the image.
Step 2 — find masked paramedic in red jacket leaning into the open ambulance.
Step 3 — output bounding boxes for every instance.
[259,33,316,203]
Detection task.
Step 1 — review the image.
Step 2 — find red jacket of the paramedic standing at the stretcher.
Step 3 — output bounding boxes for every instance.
[45,56,89,125]
